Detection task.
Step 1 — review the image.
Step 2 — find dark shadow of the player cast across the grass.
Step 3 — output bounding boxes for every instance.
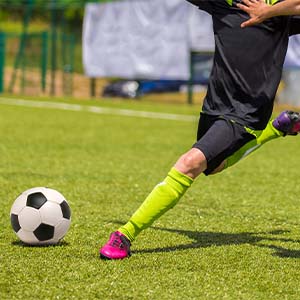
[114,221,300,258]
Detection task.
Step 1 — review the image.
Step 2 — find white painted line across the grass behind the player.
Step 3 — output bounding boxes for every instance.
[0,97,198,122]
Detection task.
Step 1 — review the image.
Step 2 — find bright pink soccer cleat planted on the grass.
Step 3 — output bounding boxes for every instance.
[99,231,131,259]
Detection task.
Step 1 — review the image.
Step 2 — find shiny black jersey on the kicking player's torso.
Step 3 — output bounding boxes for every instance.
[189,0,300,130]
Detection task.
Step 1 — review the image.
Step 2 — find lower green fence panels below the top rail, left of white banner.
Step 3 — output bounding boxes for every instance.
[0,31,75,95]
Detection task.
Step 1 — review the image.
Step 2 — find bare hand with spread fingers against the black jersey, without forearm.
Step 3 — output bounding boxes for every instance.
[237,0,270,27]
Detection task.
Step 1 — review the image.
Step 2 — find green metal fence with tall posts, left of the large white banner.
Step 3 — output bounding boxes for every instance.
[0,0,75,95]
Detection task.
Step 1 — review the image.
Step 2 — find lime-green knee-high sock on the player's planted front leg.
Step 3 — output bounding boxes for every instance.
[118,168,193,241]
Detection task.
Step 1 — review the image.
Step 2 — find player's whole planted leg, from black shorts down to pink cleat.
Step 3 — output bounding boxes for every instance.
[100,116,255,259]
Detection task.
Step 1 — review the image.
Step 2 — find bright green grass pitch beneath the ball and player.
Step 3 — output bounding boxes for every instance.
[0,97,300,300]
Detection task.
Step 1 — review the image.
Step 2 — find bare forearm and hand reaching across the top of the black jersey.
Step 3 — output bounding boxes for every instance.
[237,0,300,27]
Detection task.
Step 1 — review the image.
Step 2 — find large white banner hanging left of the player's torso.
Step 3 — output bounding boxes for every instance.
[83,0,214,80]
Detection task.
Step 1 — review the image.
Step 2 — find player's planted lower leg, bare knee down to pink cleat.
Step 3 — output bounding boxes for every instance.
[100,149,206,259]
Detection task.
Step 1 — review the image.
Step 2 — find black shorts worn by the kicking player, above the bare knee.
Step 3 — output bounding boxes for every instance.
[193,113,255,175]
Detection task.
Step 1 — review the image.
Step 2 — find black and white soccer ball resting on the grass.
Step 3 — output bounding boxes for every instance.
[10,187,71,245]
